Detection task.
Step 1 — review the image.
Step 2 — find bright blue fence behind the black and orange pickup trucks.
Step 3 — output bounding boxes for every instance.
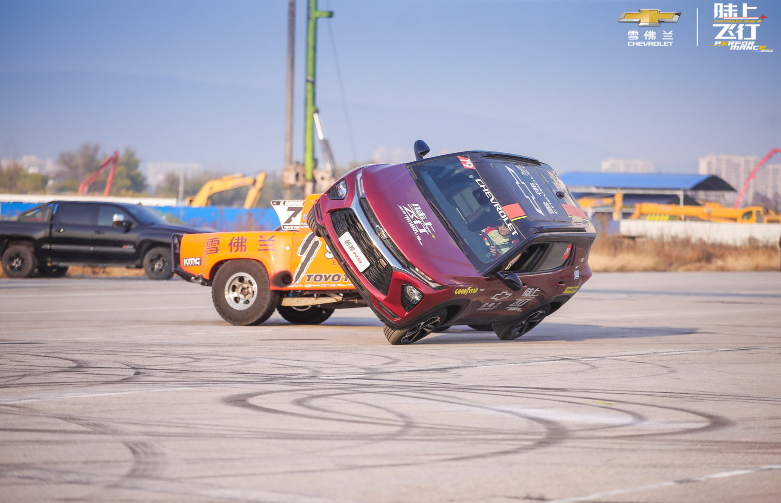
[0,203,279,231]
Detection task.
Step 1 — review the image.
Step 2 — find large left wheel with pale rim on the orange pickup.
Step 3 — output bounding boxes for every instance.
[212,259,279,326]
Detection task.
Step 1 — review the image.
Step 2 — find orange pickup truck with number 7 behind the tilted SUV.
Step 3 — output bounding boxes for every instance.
[171,194,366,325]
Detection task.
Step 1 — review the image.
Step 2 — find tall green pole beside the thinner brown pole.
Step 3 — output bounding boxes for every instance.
[304,0,334,196]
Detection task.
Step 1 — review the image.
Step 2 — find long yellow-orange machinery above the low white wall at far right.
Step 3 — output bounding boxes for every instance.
[629,203,781,224]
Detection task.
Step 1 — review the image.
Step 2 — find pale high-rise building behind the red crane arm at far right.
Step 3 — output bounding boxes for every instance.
[699,154,781,206]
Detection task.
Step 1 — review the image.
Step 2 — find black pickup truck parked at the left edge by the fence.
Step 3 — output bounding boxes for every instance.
[0,201,206,279]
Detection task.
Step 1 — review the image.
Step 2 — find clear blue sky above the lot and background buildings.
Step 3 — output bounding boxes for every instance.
[0,0,781,177]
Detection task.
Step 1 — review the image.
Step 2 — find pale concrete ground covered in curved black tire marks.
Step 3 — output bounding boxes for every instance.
[0,273,781,503]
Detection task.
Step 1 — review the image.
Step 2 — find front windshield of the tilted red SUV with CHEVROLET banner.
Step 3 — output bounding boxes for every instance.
[409,156,522,273]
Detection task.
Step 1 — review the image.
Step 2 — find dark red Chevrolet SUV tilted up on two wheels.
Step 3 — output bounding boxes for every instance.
[307,144,596,344]
